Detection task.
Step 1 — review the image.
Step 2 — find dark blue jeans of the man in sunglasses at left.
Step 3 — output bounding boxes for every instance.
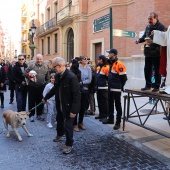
[15,84,27,112]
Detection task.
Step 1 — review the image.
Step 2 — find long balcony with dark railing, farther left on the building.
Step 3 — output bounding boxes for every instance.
[36,17,57,36]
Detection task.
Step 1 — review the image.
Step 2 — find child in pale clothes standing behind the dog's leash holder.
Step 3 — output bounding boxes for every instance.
[43,73,56,128]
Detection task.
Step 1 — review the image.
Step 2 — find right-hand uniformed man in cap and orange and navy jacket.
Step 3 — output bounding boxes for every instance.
[107,48,127,130]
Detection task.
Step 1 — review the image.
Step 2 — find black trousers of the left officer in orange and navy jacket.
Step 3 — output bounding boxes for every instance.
[97,89,108,118]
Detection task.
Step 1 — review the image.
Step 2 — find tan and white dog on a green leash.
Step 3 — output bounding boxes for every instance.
[2,110,33,142]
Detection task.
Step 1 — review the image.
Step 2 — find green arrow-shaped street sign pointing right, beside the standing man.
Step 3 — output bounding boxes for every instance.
[113,29,137,38]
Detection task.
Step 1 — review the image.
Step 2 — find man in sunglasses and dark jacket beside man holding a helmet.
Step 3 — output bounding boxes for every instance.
[13,55,27,112]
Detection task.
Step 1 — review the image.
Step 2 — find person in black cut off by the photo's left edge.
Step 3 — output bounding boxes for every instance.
[0,66,6,108]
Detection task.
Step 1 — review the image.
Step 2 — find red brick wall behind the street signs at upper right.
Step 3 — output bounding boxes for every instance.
[87,0,170,57]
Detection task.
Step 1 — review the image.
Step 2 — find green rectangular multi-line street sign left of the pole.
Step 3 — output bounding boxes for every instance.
[93,14,110,32]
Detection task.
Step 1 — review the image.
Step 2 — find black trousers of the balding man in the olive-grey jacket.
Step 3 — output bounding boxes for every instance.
[28,86,44,117]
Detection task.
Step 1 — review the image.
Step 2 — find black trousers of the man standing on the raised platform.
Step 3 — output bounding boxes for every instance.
[144,56,161,89]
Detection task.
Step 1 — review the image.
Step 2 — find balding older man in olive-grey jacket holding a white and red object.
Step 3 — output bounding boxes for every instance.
[26,54,49,122]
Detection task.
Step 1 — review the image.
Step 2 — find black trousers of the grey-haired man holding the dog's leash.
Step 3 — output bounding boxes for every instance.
[56,112,74,146]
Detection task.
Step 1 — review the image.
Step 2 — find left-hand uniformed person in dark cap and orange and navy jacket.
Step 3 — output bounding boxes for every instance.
[95,55,109,123]
